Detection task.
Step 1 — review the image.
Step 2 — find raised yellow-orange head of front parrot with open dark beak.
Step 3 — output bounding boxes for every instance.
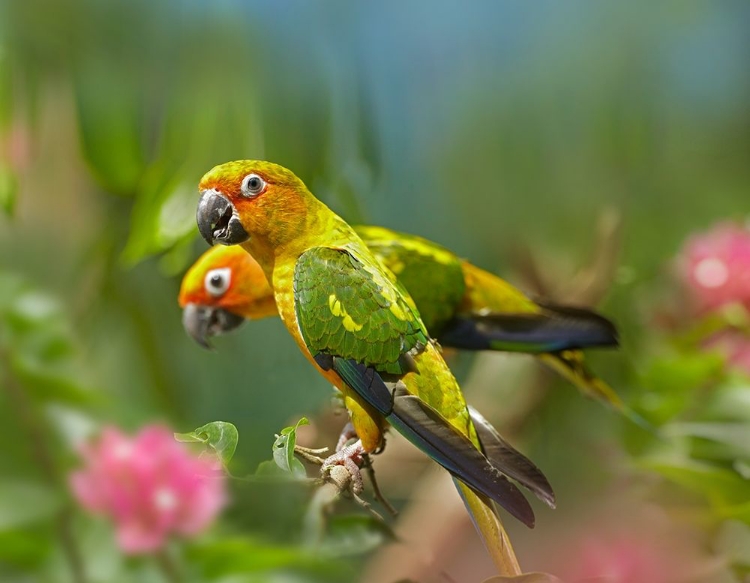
[196,160,317,248]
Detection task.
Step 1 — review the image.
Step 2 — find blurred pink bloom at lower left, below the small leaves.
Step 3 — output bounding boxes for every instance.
[70,425,226,554]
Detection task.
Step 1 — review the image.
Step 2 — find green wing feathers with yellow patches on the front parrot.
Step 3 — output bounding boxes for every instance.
[294,247,428,375]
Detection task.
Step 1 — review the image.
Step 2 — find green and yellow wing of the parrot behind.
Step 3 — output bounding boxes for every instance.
[354,226,466,337]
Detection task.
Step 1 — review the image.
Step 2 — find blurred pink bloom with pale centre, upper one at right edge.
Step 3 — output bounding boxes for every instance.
[677,223,750,314]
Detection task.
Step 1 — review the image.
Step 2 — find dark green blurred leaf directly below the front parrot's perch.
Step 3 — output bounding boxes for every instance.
[317,514,396,557]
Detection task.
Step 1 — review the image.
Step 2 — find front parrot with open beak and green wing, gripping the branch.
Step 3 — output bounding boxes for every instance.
[196,160,551,574]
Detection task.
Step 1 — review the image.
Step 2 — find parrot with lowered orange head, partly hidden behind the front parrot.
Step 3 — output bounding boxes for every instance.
[179,226,640,416]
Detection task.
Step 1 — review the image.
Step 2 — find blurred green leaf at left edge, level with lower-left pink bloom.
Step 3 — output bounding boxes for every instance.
[0,480,62,531]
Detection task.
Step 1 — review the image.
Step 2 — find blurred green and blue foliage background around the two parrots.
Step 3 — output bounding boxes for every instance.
[0,0,750,583]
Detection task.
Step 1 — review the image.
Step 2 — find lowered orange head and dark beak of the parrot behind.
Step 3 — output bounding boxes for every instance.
[179,246,277,348]
